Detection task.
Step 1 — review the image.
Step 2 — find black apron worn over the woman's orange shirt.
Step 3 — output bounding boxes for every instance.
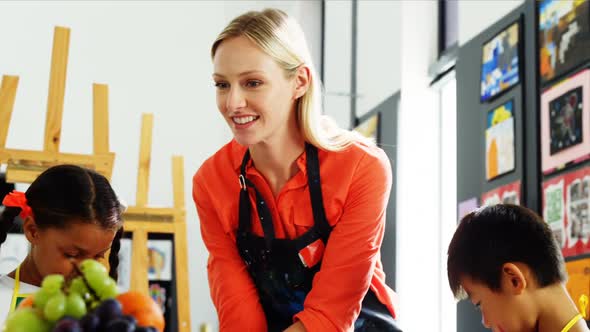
[236,144,401,332]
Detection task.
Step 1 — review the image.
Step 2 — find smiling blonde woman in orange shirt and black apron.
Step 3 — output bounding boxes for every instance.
[193,9,399,332]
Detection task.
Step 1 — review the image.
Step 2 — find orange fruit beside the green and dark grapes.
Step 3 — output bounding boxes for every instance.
[117,291,165,332]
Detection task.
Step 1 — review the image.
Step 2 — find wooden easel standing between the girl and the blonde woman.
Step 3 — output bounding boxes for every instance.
[123,114,191,332]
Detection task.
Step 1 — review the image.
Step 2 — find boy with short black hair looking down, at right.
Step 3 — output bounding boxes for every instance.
[447,204,589,332]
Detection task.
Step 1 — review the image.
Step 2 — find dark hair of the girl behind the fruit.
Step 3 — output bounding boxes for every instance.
[0,165,123,280]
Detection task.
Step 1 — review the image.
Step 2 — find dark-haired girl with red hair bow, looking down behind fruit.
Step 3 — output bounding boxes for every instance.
[0,165,123,326]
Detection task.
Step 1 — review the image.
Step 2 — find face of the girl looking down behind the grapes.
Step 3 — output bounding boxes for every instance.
[25,222,116,279]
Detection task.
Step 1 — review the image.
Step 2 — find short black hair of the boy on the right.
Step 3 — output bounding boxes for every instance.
[447,204,566,297]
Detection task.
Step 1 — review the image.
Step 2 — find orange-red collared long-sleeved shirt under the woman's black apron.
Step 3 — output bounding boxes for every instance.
[193,140,397,332]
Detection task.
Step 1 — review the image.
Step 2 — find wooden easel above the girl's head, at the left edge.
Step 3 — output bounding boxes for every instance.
[0,27,115,183]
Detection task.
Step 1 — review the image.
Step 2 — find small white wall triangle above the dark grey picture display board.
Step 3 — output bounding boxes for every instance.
[458,0,524,45]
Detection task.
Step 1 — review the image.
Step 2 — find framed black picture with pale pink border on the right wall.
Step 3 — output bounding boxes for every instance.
[541,69,590,174]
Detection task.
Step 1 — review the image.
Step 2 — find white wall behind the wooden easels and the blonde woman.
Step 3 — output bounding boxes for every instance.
[0,1,321,331]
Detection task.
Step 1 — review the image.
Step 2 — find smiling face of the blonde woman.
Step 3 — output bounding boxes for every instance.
[213,37,300,146]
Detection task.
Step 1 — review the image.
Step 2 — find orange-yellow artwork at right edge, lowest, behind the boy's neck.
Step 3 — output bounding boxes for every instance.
[565,258,590,320]
